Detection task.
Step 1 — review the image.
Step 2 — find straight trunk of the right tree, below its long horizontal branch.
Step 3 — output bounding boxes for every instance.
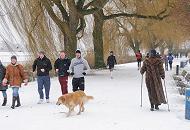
[93,10,105,68]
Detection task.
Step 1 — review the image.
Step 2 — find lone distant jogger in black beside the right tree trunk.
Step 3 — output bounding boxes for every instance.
[107,51,117,78]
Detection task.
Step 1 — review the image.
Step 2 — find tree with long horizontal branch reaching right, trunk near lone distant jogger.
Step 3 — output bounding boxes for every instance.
[93,0,168,67]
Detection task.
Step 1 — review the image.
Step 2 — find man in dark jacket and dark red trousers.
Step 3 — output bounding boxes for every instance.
[54,51,71,95]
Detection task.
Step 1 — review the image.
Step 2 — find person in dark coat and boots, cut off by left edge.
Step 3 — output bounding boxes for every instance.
[0,61,8,106]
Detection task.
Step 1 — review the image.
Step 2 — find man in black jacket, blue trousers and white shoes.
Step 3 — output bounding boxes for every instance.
[33,51,52,104]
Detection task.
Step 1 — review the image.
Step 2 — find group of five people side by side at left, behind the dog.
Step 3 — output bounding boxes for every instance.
[0,50,90,109]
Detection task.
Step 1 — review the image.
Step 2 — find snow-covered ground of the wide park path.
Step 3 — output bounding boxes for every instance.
[0,59,190,130]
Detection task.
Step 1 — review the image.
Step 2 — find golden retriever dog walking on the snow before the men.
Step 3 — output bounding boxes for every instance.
[56,90,93,117]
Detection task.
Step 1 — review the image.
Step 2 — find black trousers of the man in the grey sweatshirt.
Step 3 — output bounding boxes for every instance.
[72,77,84,92]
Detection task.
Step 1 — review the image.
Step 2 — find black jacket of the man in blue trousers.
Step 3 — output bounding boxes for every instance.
[32,56,52,76]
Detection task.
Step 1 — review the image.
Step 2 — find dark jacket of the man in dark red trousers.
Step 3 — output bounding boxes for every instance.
[54,58,71,76]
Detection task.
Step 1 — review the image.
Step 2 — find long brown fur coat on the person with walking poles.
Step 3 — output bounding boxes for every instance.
[140,57,166,105]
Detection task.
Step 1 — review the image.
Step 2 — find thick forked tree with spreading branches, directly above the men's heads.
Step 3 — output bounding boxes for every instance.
[39,0,108,57]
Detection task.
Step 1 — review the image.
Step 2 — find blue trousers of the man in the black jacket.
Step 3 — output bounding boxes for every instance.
[37,76,51,99]
